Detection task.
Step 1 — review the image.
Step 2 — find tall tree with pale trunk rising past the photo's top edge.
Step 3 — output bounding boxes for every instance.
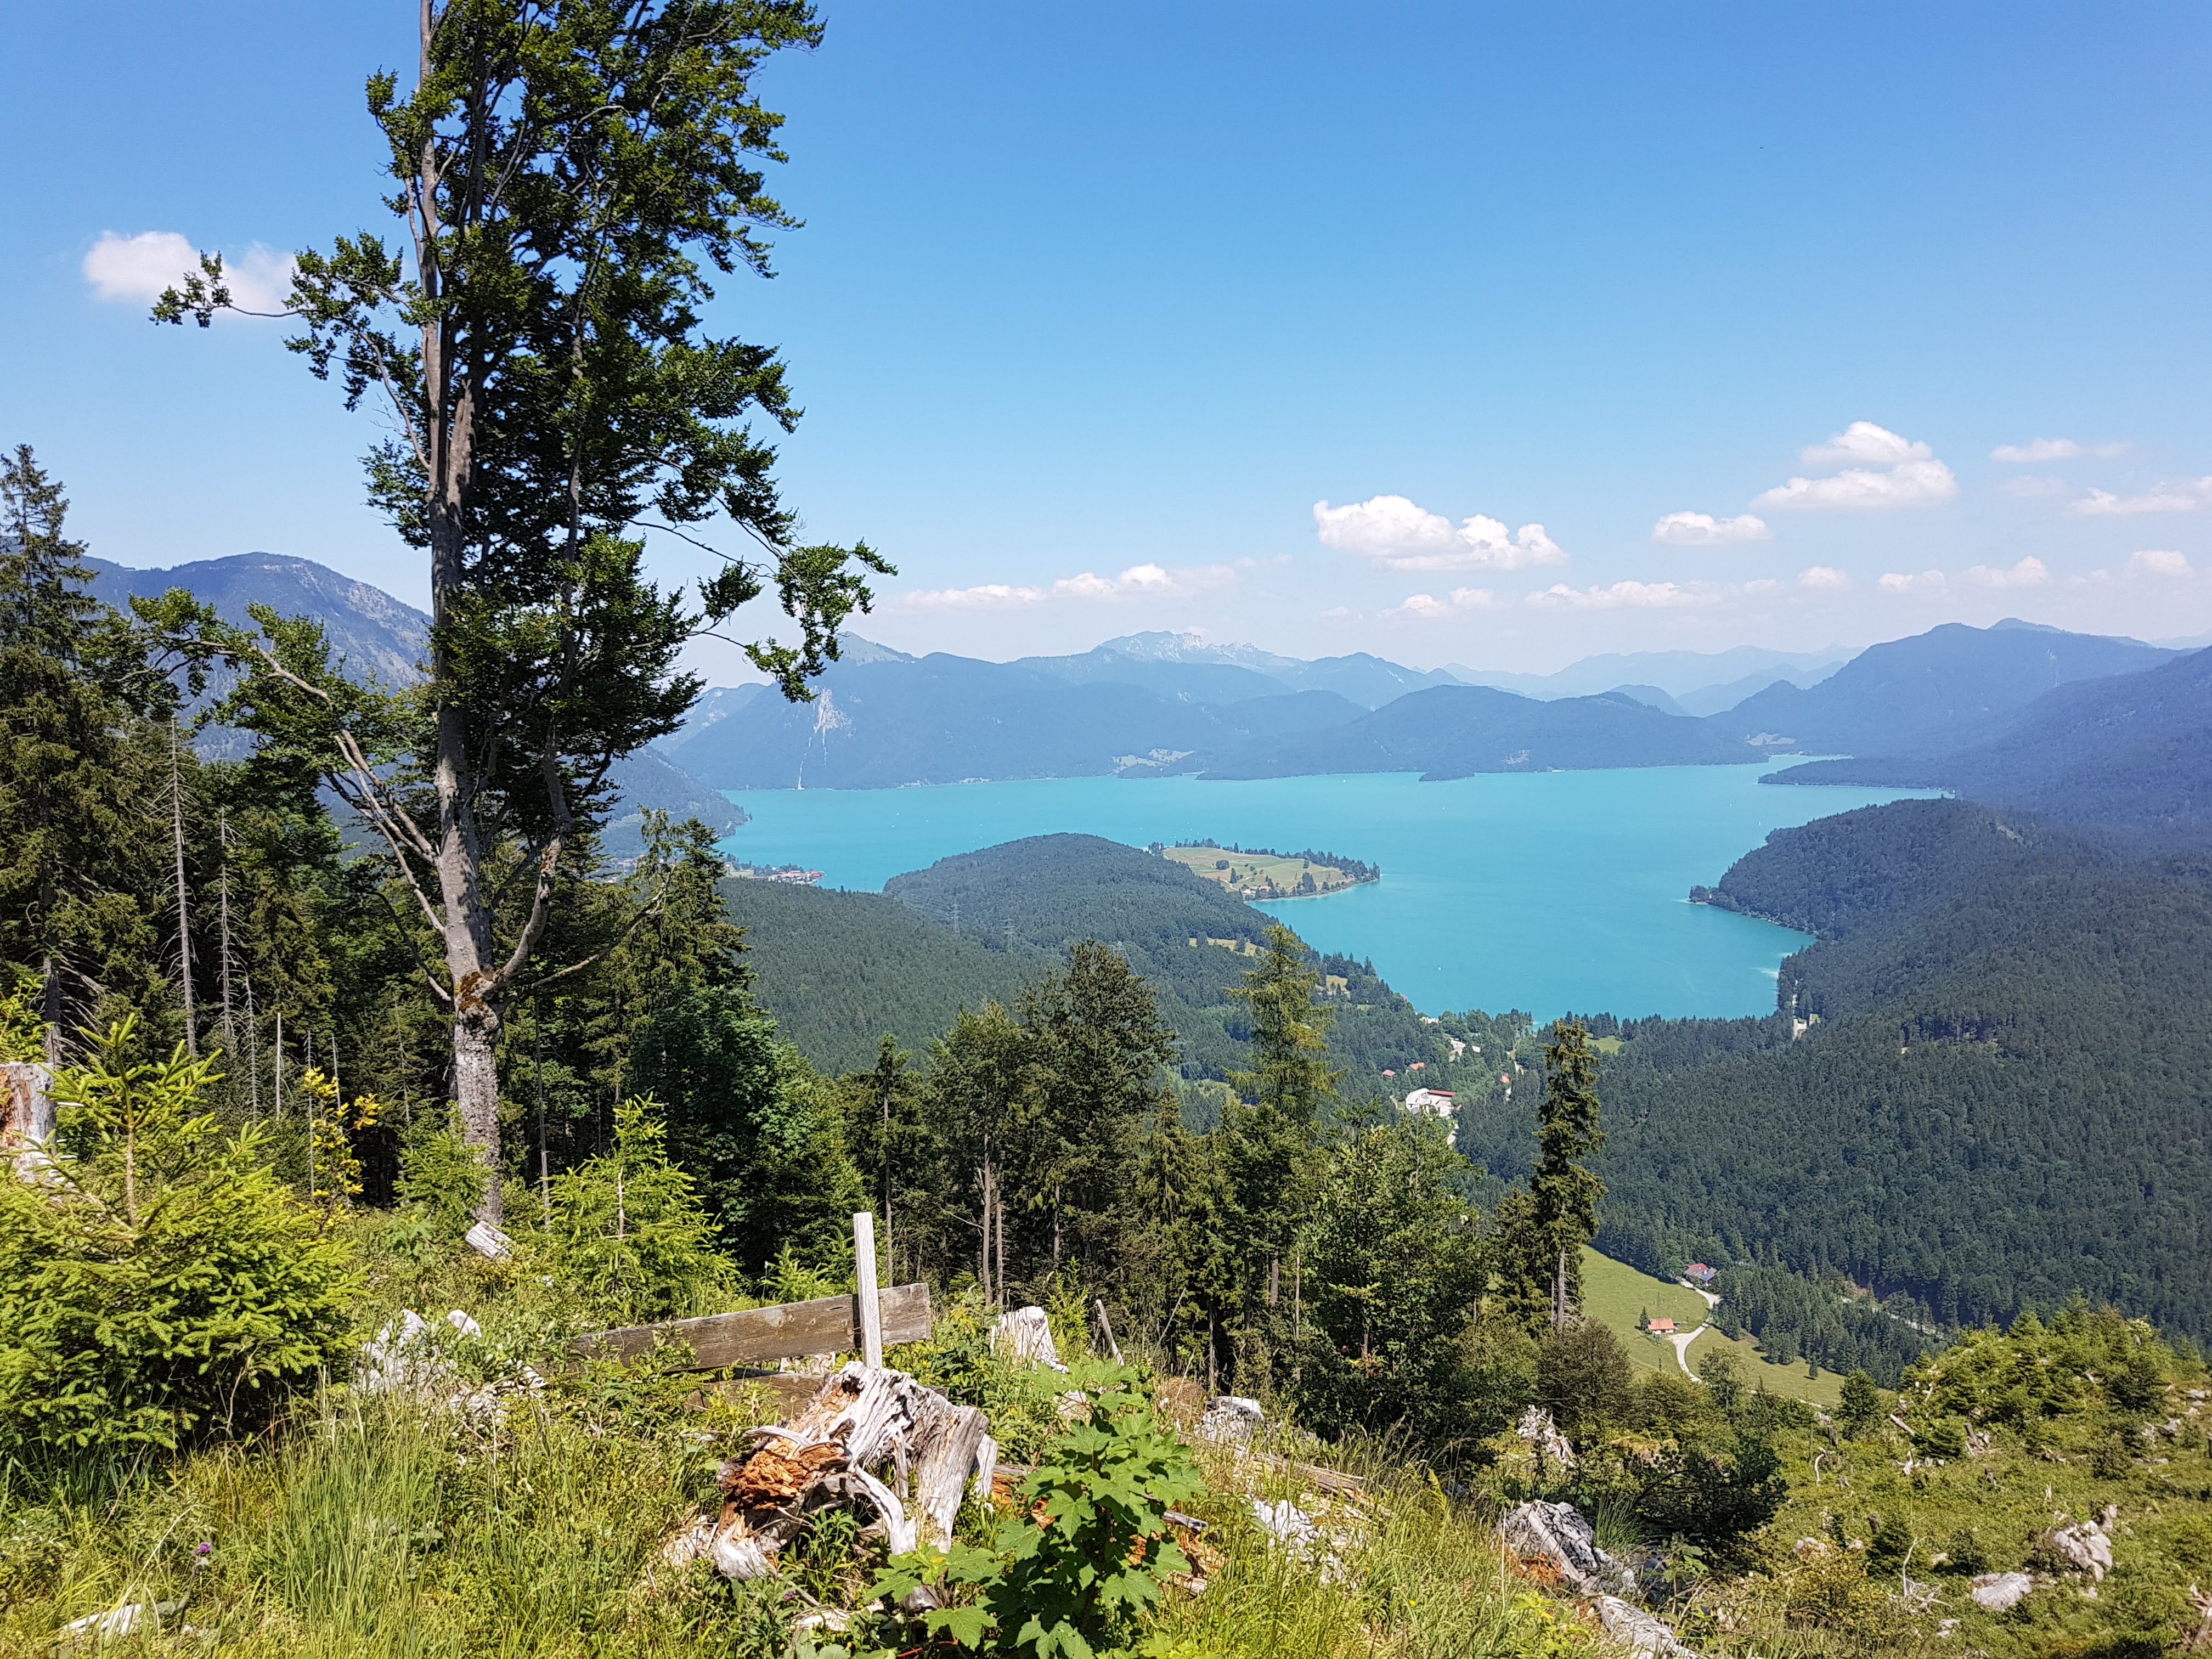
[155,0,891,1219]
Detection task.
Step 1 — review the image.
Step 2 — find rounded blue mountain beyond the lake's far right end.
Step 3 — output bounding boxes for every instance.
[1712,622,2174,754]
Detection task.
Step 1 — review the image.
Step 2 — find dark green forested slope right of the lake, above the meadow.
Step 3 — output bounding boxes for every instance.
[1462,801,2212,1336]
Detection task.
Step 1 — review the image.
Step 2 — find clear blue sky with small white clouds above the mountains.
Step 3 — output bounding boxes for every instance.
[0,0,2212,677]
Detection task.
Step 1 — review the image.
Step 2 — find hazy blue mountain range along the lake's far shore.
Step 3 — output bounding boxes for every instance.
[666,622,2181,789]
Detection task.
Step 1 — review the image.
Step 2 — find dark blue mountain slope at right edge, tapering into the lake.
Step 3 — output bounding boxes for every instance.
[1772,650,2212,845]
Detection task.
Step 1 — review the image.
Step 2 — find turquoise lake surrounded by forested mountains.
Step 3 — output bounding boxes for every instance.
[721,765,1914,1020]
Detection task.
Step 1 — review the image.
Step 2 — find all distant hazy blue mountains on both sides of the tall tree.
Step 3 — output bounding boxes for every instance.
[78,553,2212,822]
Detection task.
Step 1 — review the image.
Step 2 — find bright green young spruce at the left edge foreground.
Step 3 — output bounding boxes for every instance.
[0,1020,356,1449]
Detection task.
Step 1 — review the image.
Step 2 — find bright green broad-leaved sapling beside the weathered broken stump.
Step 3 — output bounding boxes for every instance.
[854,1363,1203,1659]
